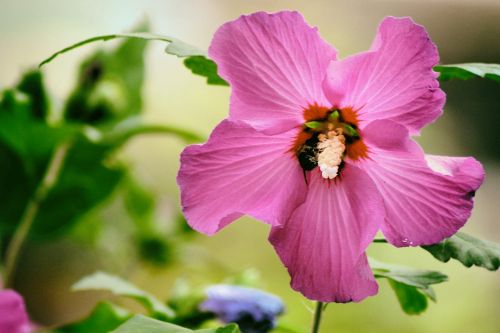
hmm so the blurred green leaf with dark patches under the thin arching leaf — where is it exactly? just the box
[64,23,148,124]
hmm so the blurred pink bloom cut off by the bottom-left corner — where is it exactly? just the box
[0,289,31,333]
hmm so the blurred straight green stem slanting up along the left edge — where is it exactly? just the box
[5,142,71,288]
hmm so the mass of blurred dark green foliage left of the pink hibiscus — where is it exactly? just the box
[0,22,202,265]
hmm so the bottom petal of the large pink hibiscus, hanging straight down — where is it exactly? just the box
[269,165,384,302]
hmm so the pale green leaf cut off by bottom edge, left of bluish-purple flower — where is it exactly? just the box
[113,315,193,333]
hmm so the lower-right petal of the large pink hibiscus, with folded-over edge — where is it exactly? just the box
[359,121,484,246]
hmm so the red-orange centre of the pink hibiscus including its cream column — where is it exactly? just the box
[294,105,367,179]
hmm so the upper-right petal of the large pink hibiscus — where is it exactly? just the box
[324,17,445,134]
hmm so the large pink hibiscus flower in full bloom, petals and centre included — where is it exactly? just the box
[178,12,484,302]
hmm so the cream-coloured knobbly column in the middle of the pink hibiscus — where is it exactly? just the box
[317,128,346,179]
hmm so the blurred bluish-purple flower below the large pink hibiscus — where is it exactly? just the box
[200,284,284,333]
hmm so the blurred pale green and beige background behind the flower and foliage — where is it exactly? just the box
[0,0,500,333]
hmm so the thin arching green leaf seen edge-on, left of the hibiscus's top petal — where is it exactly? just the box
[39,32,205,67]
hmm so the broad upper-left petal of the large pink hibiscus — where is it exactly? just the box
[209,11,336,133]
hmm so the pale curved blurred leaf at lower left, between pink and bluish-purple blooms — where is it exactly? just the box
[72,272,174,319]
